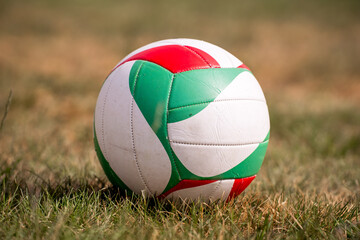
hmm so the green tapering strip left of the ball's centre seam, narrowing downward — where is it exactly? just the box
[129,60,180,191]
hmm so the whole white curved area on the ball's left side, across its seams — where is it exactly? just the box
[95,61,171,195]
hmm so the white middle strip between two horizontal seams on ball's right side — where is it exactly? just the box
[168,100,270,145]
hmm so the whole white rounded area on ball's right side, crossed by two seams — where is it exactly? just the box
[168,72,270,177]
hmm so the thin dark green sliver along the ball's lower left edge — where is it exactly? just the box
[94,126,132,194]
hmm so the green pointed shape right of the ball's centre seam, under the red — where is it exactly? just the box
[168,68,247,123]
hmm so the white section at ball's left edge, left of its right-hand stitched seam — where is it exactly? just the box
[95,62,145,193]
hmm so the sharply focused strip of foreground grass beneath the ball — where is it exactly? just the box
[0,157,360,239]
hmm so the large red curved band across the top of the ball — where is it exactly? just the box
[114,45,220,73]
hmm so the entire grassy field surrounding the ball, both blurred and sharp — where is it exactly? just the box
[0,0,360,239]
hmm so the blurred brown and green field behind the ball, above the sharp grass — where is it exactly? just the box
[0,0,360,198]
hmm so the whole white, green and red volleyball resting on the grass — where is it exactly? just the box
[94,39,270,201]
